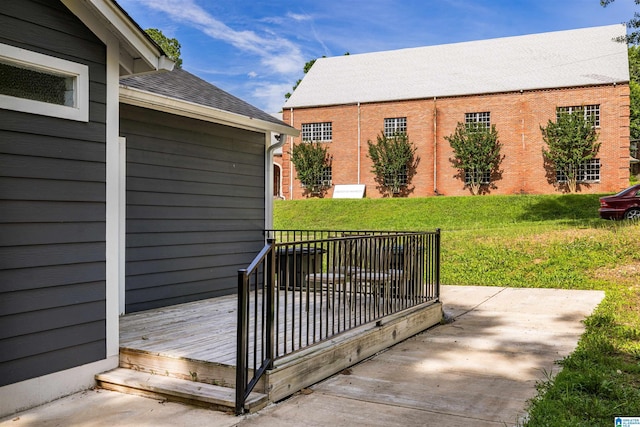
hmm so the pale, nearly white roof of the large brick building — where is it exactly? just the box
[285,24,629,108]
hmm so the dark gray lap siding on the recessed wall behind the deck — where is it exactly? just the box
[120,105,265,312]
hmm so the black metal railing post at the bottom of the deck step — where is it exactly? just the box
[236,269,249,415]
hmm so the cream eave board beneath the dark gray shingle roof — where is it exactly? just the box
[120,85,300,137]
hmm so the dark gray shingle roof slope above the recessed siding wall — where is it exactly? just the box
[120,69,288,126]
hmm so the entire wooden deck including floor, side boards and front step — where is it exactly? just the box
[111,291,442,411]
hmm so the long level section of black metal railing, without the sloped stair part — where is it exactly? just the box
[268,230,440,359]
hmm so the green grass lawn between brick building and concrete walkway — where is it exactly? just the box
[274,195,640,427]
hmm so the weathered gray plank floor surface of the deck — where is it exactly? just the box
[120,292,384,366]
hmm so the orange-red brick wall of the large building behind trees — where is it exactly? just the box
[282,84,629,199]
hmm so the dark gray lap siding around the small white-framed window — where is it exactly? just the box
[0,0,106,386]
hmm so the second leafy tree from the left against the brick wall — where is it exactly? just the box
[367,131,419,196]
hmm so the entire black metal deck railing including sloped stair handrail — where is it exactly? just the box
[236,230,440,413]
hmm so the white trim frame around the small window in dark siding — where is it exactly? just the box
[0,43,89,122]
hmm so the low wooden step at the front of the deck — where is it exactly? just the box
[96,368,268,412]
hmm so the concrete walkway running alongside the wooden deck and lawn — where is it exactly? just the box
[0,286,604,427]
